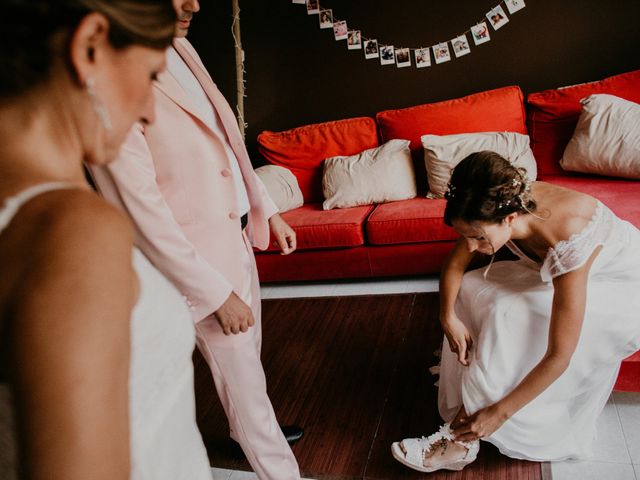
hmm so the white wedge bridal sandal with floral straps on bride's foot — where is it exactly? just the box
[391,423,480,473]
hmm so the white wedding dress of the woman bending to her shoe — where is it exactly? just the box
[438,202,640,460]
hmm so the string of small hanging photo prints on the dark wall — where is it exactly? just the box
[292,0,525,68]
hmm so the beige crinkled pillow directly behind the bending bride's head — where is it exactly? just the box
[420,132,538,198]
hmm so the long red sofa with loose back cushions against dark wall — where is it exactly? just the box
[256,70,640,391]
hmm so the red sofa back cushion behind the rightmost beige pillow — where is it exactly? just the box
[527,70,640,175]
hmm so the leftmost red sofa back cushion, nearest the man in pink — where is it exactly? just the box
[258,117,378,202]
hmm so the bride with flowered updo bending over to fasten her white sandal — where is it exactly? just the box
[392,152,640,472]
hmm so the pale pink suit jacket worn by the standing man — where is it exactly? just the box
[90,39,277,322]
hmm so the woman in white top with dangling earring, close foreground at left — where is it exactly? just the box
[0,0,211,480]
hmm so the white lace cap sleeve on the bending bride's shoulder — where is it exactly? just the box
[540,202,615,282]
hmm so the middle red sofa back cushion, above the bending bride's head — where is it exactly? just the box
[376,86,527,152]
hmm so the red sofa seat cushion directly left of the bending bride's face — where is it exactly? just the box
[366,197,458,245]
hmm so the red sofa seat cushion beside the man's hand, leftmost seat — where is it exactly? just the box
[268,203,373,251]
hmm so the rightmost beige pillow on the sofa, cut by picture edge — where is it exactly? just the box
[560,95,640,178]
